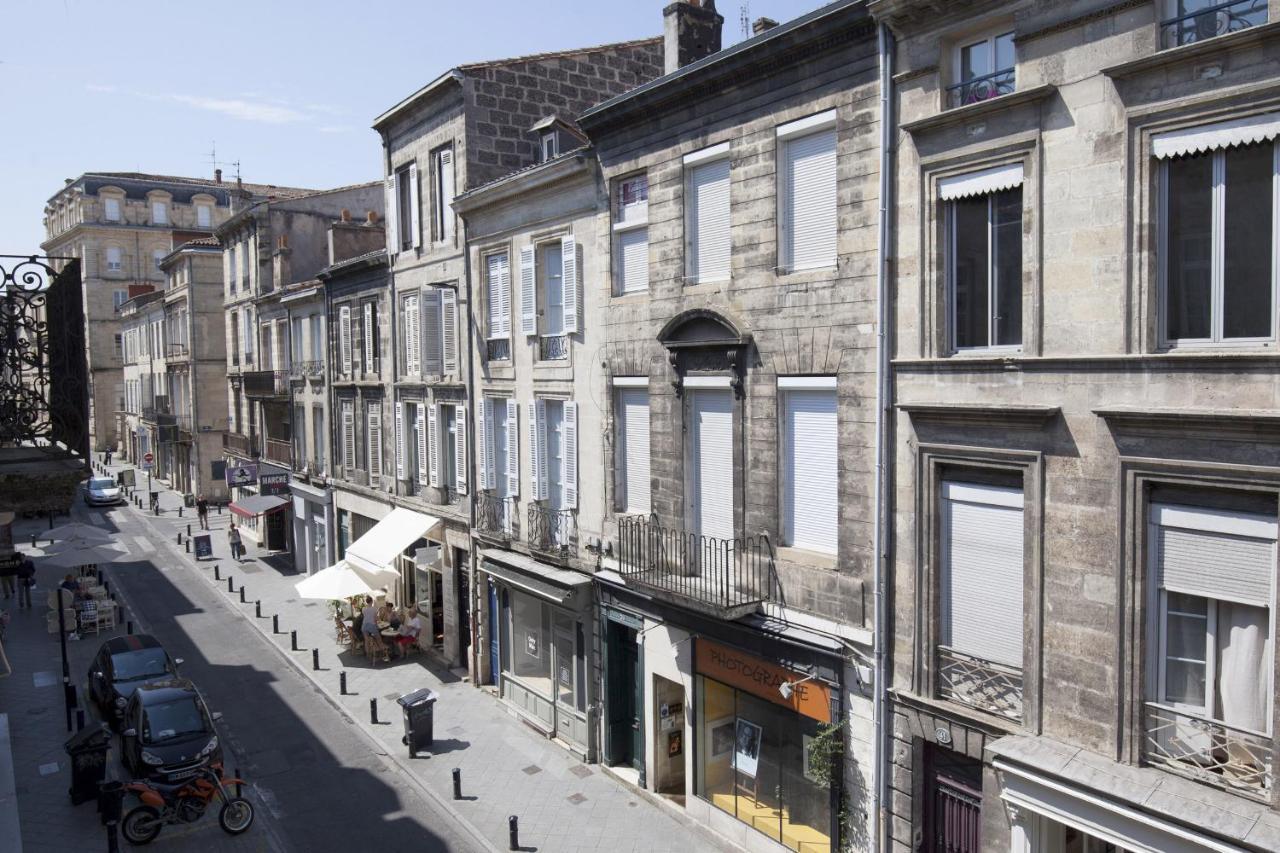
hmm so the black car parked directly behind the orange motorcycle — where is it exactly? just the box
[120,679,223,783]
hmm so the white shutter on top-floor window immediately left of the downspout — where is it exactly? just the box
[782,128,836,269]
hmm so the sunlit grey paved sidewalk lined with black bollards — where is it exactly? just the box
[94,455,737,853]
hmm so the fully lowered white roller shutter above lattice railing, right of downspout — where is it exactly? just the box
[938,483,1023,669]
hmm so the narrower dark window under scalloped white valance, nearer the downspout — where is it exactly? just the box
[938,165,1023,350]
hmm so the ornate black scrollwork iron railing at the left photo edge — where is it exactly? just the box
[0,255,88,460]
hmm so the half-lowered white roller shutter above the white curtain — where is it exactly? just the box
[1151,505,1276,607]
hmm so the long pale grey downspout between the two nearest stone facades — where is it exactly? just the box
[872,23,895,850]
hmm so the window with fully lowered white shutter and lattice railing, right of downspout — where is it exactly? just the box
[937,480,1024,721]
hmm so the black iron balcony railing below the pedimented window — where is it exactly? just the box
[618,516,777,619]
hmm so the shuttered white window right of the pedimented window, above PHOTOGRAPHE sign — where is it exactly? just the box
[778,377,840,555]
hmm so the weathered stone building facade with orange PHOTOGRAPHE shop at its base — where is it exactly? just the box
[579,1,879,850]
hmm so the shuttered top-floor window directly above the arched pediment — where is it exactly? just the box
[685,142,732,284]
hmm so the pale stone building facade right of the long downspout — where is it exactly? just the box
[870,0,1280,850]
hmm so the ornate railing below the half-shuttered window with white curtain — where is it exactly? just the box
[1142,702,1274,802]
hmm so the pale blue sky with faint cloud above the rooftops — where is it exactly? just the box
[0,0,824,254]
